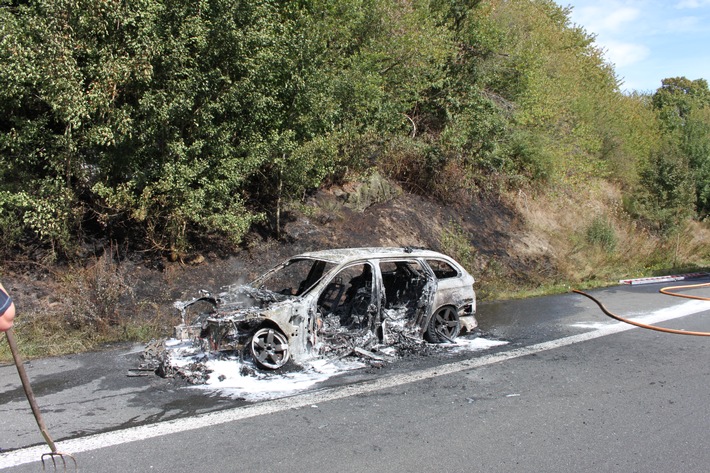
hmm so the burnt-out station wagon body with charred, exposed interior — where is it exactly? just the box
[176,248,478,369]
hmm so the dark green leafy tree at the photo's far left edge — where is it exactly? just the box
[0,0,159,254]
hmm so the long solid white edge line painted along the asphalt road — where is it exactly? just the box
[0,301,710,469]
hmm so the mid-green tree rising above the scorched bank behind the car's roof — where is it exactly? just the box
[256,0,450,226]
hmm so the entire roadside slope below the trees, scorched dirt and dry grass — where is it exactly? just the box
[0,171,710,357]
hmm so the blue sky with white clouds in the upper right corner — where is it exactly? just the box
[556,0,710,92]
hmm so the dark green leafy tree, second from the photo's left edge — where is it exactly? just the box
[92,0,278,257]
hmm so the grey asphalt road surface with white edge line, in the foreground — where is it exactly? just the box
[0,279,710,472]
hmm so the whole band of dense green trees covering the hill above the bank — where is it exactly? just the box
[0,0,710,257]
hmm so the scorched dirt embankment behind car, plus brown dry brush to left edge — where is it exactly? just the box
[2,176,554,338]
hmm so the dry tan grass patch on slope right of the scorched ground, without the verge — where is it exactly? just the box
[515,181,710,285]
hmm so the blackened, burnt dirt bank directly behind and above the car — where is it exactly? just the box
[150,175,556,298]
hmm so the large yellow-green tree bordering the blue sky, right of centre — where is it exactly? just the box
[420,0,636,190]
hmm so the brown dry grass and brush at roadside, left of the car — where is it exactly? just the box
[0,253,175,361]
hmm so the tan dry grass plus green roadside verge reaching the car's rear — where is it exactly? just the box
[474,181,710,300]
